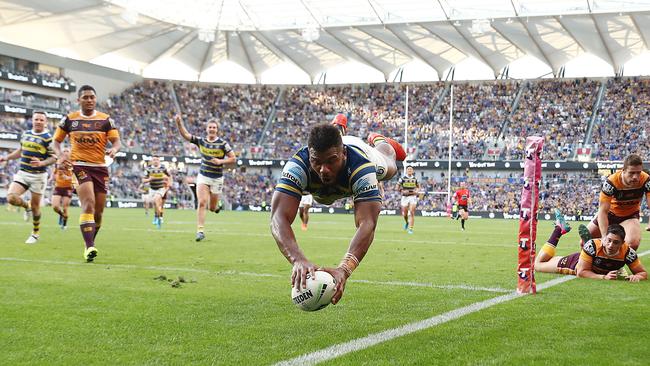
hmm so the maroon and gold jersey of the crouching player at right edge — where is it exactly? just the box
[600,171,650,217]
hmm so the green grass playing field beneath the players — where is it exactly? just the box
[0,208,650,365]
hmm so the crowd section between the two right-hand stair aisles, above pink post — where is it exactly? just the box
[503,79,600,160]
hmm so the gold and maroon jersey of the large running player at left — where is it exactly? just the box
[54,111,119,166]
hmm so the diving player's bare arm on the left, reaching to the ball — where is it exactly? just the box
[271,191,316,289]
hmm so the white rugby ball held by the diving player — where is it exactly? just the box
[291,271,336,311]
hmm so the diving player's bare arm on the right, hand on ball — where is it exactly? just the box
[325,201,381,305]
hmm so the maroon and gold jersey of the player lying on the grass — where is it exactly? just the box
[580,239,641,275]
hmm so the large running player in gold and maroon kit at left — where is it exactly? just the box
[53,85,121,262]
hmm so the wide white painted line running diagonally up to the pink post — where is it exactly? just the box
[275,250,650,366]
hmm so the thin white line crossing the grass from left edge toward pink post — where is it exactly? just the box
[0,257,511,293]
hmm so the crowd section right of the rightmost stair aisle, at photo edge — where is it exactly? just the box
[591,78,650,160]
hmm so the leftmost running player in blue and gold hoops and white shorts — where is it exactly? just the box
[0,112,56,244]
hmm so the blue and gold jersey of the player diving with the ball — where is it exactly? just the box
[275,145,381,205]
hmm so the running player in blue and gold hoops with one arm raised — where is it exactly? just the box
[174,115,235,241]
